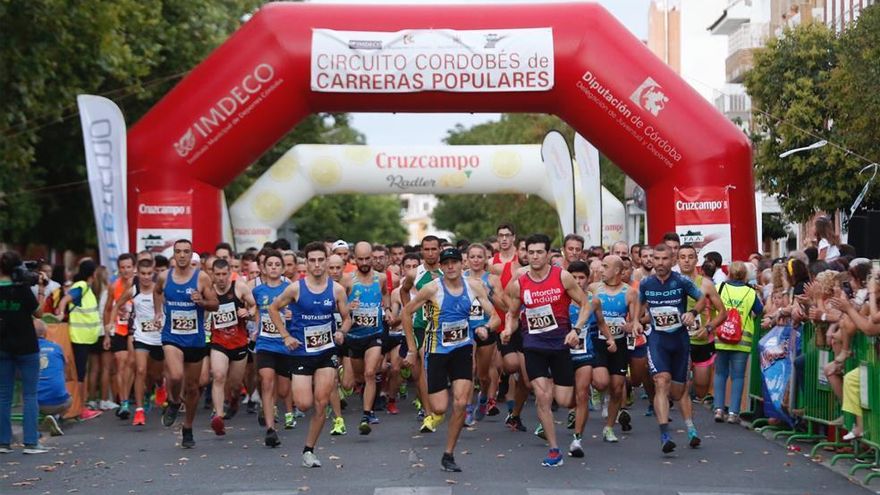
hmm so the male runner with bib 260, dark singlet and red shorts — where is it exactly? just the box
[211,258,257,435]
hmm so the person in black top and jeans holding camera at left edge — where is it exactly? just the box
[0,251,47,454]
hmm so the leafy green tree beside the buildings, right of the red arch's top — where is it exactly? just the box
[745,23,862,221]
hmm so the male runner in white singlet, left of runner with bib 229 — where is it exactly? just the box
[110,259,165,426]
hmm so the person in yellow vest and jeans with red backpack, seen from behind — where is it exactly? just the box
[715,261,764,424]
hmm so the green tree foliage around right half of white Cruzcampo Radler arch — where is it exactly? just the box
[434,114,625,240]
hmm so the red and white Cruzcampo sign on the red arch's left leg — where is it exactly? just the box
[137,191,192,257]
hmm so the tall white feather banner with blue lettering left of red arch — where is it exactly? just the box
[76,95,128,268]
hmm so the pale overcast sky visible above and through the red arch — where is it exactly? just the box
[311,0,650,145]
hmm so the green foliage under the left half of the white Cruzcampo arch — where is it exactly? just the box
[293,194,406,246]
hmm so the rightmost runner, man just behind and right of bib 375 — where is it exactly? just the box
[678,244,727,404]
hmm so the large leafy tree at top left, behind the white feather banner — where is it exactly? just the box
[0,0,262,249]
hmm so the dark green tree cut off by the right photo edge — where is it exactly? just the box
[829,5,880,208]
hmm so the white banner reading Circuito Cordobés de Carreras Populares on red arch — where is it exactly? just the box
[311,28,554,93]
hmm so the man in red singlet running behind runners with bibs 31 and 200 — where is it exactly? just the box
[486,223,529,431]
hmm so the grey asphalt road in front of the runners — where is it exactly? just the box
[0,392,871,495]
